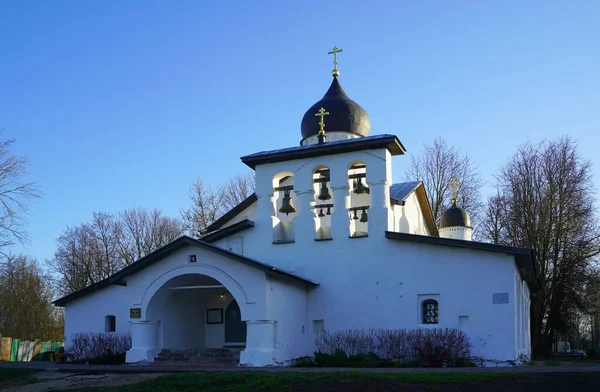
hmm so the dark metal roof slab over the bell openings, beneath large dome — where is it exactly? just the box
[240,134,406,169]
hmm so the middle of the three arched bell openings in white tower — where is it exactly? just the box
[312,166,334,240]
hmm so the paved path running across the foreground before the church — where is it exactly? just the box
[0,362,600,374]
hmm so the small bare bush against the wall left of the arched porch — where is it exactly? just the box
[66,333,131,364]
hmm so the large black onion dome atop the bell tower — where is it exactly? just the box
[301,77,371,140]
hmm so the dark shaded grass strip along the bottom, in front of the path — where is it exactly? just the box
[65,372,600,392]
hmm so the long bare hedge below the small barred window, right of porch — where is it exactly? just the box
[295,328,471,367]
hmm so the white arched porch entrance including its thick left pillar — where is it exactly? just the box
[127,268,253,362]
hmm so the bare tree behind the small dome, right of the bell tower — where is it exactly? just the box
[404,138,483,230]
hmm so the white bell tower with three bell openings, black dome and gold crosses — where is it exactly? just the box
[242,47,405,245]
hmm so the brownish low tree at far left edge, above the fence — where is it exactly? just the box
[0,255,63,340]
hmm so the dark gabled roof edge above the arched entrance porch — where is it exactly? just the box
[53,236,319,306]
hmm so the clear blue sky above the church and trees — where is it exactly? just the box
[0,0,600,260]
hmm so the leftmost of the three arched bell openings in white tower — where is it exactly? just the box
[273,171,297,243]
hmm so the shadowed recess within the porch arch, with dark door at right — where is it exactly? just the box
[146,273,246,351]
